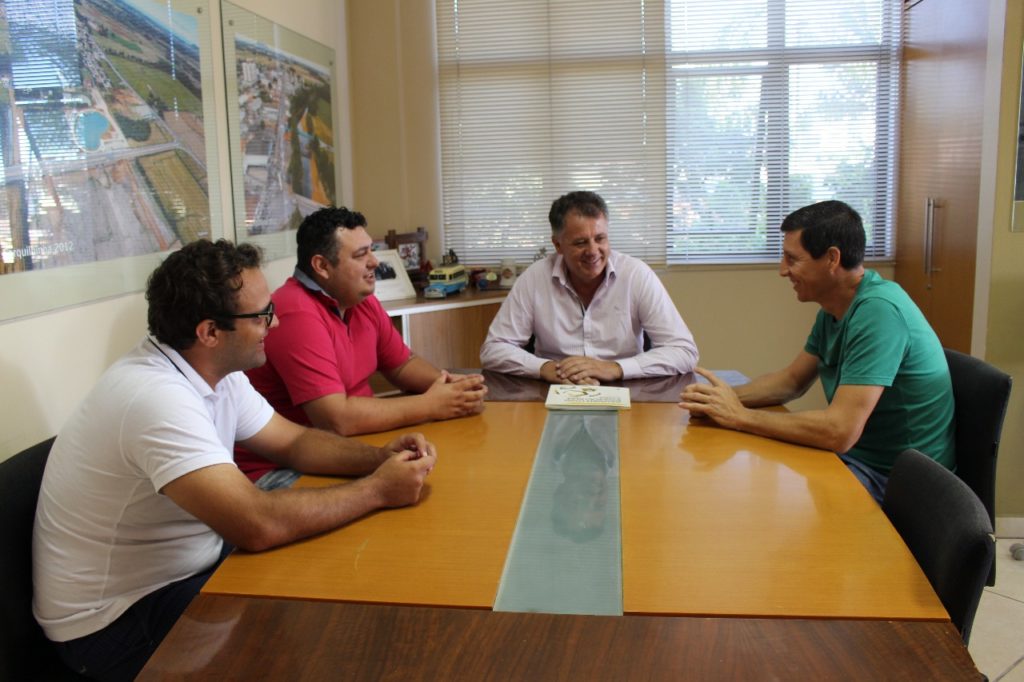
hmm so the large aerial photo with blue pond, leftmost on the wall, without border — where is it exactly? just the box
[0,0,210,274]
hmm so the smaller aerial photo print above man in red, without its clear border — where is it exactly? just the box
[234,35,335,236]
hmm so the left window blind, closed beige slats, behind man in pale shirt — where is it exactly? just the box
[437,0,665,264]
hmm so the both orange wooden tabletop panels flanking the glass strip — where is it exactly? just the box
[204,402,947,621]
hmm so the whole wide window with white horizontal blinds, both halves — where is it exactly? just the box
[437,0,901,264]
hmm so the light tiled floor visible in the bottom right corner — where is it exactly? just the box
[968,538,1024,682]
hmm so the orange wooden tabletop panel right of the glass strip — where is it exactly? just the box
[620,403,947,620]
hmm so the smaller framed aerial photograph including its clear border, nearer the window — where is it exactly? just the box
[221,1,339,258]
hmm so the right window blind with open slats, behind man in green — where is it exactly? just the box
[666,0,901,263]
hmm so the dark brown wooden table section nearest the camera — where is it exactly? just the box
[137,594,980,682]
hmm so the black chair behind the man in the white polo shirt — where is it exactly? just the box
[0,438,85,680]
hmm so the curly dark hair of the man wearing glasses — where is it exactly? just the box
[145,240,262,350]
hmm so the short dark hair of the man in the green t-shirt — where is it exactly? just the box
[780,200,866,270]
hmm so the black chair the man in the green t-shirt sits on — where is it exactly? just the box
[945,348,1013,585]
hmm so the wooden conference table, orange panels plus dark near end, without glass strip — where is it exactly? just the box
[139,374,979,679]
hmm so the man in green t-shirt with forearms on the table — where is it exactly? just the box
[679,201,955,502]
